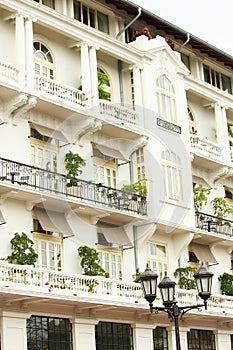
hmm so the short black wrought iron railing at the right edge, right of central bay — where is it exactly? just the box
[196,212,233,237]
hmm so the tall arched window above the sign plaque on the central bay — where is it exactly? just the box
[156,74,177,124]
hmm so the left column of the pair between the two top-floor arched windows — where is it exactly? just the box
[81,42,91,97]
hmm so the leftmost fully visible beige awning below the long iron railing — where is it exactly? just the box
[34,208,74,236]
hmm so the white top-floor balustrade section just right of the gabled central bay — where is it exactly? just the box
[190,135,222,160]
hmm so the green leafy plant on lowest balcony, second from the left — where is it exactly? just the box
[78,246,105,276]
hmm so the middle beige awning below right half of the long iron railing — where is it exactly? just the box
[97,226,133,247]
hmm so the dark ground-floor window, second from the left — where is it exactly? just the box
[95,322,133,350]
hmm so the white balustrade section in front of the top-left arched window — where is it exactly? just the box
[35,76,88,107]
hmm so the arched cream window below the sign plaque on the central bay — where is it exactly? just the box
[161,150,183,200]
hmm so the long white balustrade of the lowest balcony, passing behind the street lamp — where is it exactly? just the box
[0,261,233,317]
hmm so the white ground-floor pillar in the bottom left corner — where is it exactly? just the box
[0,311,29,350]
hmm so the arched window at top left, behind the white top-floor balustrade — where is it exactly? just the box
[33,41,54,79]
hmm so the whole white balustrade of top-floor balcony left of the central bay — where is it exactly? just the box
[0,61,139,126]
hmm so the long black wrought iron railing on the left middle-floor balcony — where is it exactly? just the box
[0,158,147,215]
